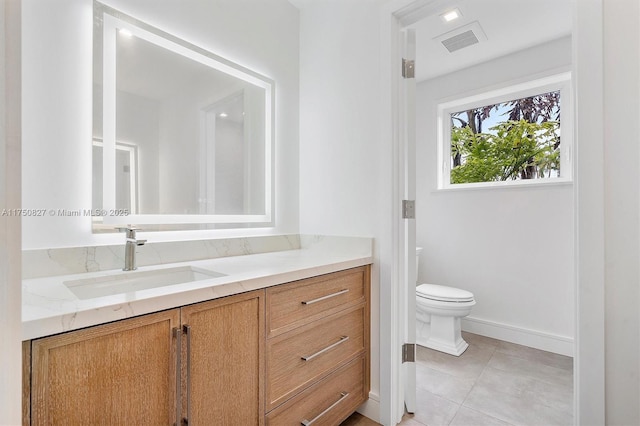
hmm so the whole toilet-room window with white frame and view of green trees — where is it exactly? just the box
[438,73,572,189]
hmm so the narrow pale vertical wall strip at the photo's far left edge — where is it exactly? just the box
[0,1,22,425]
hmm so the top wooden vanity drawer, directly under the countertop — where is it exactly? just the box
[267,267,369,337]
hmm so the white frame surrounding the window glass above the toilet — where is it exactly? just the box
[437,72,573,190]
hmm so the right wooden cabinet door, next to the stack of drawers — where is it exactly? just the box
[182,290,265,426]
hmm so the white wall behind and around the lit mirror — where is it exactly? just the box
[22,0,299,249]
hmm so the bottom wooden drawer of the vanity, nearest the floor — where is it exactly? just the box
[266,356,369,426]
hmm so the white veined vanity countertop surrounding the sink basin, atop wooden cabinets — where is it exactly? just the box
[22,244,372,340]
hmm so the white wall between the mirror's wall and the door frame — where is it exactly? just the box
[296,0,392,418]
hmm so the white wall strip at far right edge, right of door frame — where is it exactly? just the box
[604,0,640,425]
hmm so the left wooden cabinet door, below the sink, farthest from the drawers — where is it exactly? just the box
[31,309,180,425]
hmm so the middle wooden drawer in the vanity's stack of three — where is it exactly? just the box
[267,305,367,410]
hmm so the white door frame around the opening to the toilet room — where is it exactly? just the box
[380,0,605,425]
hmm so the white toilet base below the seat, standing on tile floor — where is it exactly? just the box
[416,315,469,356]
